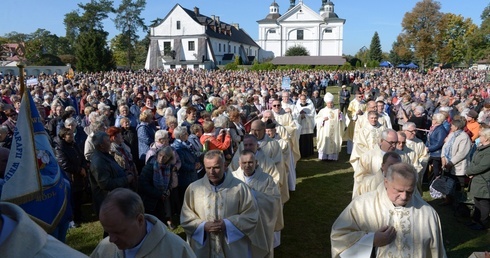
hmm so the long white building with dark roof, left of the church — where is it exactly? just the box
[145,4,260,69]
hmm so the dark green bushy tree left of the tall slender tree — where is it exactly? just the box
[75,30,115,72]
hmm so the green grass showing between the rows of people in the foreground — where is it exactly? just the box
[67,87,490,258]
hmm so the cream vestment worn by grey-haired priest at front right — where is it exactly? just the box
[330,184,446,258]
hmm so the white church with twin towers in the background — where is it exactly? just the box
[257,0,345,57]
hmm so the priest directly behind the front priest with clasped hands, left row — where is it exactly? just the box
[233,150,284,257]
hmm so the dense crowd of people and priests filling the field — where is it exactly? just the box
[0,68,490,257]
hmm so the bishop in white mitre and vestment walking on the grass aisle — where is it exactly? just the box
[315,92,345,160]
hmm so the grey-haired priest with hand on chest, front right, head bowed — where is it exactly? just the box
[330,163,447,258]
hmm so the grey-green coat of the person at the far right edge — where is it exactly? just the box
[466,144,490,199]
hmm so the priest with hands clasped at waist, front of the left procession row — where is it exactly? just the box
[180,150,261,258]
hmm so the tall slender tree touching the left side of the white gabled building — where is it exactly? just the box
[114,0,147,69]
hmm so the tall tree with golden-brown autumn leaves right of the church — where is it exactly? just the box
[402,0,442,69]
